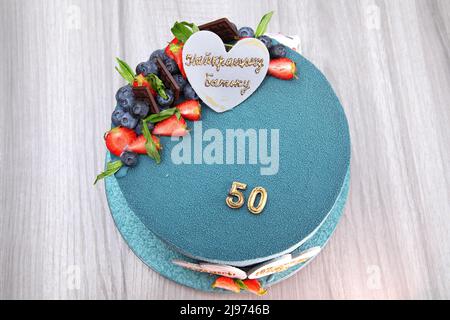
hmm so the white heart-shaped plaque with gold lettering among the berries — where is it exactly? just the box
[183,31,270,112]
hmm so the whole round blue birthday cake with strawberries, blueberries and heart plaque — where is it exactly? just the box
[96,12,350,294]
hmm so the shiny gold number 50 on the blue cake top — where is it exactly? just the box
[225,182,267,214]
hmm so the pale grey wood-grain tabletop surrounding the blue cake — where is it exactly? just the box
[0,0,450,299]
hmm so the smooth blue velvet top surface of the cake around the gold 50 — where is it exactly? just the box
[112,51,350,266]
